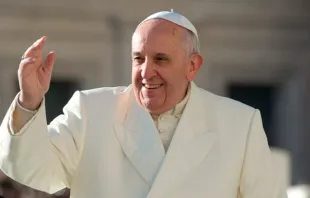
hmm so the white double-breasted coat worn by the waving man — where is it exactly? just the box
[0,83,286,198]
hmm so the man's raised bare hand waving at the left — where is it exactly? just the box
[18,36,55,110]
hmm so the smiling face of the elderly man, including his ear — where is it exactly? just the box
[132,19,202,114]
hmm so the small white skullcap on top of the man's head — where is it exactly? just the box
[139,10,198,40]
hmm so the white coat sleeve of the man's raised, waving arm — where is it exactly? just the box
[0,92,87,194]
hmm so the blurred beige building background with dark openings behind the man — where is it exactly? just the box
[0,0,310,198]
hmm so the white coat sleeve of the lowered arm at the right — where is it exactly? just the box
[240,110,287,198]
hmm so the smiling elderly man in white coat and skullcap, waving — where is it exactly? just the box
[0,11,286,198]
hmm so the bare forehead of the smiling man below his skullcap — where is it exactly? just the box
[132,19,186,53]
